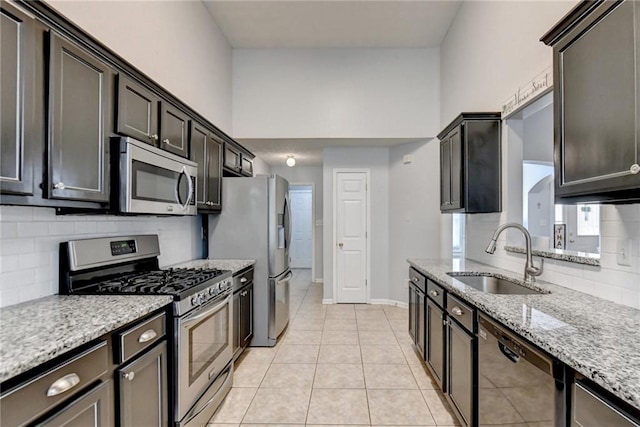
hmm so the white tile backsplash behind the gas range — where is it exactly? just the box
[0,206,202,307]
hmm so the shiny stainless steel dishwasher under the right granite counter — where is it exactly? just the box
[478,314,566,426]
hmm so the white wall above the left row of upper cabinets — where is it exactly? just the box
[47,0,232,134]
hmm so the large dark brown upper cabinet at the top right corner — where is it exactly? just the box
[541,0,640,204]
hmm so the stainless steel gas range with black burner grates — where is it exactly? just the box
[59,235,233,427]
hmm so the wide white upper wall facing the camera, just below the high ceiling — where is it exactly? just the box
[233,49,440,139]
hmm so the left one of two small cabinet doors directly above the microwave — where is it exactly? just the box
[116,74,160,145]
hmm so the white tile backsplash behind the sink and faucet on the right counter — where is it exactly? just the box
[466,204,640,308]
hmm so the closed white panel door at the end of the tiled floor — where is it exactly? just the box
[334,172,369,303]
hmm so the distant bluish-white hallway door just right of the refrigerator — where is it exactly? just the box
[289,186,313,268]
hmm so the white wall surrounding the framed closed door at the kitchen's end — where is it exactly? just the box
[323,147,389,300]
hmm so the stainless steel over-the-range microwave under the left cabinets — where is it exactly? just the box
[112,137,198,215]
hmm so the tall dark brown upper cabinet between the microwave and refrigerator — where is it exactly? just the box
[191,121,223,211]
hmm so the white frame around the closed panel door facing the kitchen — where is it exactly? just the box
[331,168,371,304]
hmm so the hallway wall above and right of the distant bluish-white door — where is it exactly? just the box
[271,166,324,282]
